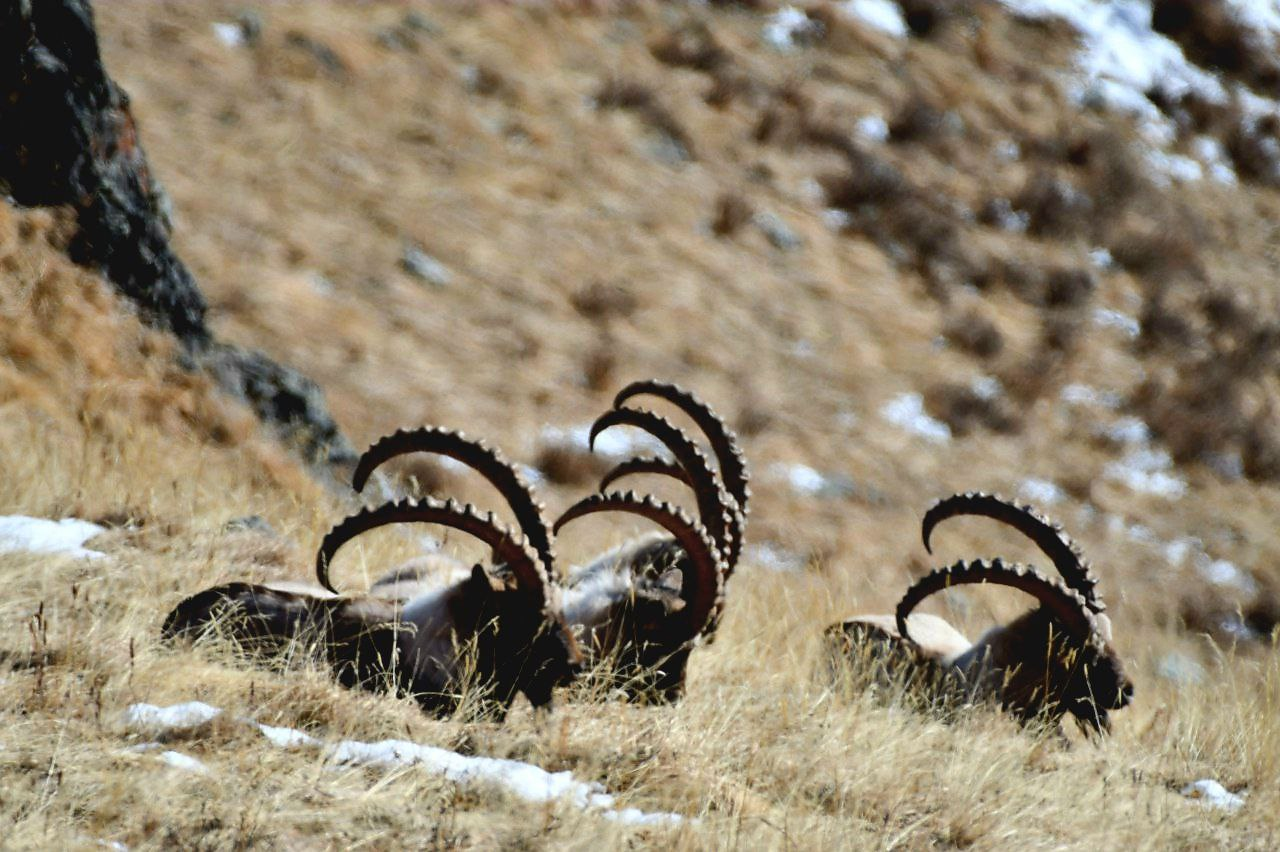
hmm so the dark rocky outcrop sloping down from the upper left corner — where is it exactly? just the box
[0,0,355,467]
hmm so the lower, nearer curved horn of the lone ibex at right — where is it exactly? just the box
[895,559,1097,640]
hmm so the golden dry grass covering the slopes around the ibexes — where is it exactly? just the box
[0,0,1280,848]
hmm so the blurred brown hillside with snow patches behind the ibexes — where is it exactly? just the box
[0,0,1280,654]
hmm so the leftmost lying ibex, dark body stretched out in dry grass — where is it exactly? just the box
[164,430,581,716]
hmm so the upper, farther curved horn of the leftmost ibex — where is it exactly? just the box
[351,426,556,576]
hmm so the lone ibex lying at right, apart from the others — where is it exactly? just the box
[827,495,1133,730]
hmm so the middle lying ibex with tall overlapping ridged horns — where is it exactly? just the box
[545,381,750,701]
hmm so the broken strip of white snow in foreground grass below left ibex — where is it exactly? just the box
[124,701,685,825]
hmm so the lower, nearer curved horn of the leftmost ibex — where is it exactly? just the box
[316,498,547,605]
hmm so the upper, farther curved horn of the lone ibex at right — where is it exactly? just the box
[920,491,1106,613]
